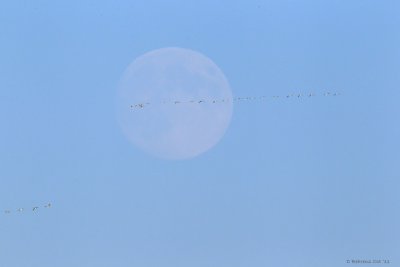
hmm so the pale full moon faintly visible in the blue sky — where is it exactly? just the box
[117,47,233,160]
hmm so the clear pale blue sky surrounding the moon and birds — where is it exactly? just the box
[0,0,400,267]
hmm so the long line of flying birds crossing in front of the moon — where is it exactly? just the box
[131,92,340,109]
